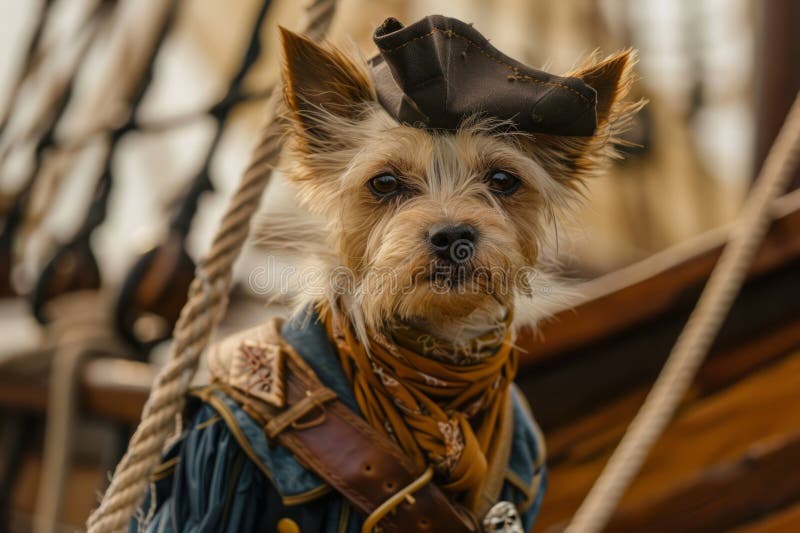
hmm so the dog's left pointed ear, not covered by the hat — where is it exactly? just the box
[280,28,375,150]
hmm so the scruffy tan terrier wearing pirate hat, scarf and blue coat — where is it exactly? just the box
[138,16,642,532]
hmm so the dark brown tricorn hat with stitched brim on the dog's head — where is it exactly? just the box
[370,15,597,136]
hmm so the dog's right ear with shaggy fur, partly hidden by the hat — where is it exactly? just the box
[532,49,645,185]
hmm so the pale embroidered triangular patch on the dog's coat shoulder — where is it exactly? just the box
[208,319,286,408]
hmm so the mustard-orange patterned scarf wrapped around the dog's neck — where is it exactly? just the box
[325,312,517,510]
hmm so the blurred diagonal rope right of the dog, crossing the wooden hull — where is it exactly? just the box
[566,93,800,533]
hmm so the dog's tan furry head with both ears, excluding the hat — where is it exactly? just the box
[283,31,635,327]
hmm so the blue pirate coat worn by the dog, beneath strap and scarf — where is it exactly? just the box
[130,317,546,533]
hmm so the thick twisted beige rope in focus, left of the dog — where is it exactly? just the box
[87,0,335,533]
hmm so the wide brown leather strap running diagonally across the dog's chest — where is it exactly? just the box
[223,336,480,533]
